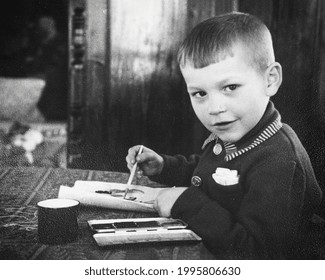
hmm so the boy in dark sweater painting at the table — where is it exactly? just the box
[126,13,322,259]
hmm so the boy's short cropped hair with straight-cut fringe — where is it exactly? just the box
[178,12,275,71]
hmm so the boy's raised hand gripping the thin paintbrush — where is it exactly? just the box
[126,145,164,176]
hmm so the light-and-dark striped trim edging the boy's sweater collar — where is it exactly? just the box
[202,116,282,161]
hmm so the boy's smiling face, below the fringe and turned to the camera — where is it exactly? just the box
[181,43,269,143]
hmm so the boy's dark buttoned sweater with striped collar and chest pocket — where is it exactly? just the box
[154,102,322,259]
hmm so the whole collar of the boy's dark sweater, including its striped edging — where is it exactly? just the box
[202,101,282,161]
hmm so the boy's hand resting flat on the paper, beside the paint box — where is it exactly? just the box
[153,187,187,217]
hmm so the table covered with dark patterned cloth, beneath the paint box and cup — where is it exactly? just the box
[0,167,213,260]
